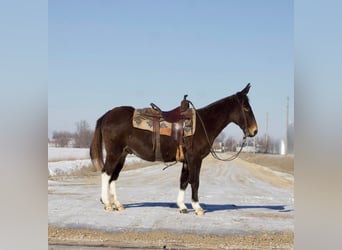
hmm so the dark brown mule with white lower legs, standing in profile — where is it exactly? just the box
[90,84,258,215]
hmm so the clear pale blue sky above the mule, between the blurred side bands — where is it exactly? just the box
[48,0,294,141]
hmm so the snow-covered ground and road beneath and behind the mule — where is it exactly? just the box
[48,146,294,235]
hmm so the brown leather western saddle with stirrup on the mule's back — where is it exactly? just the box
[144,95,192,161]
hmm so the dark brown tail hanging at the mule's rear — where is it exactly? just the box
[90,117,104,170]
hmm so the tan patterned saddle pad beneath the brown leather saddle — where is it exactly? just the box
[132,108,196,137]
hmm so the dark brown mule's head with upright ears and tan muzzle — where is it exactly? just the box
[235,83,258,137]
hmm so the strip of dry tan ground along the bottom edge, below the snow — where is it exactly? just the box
[48,226,294,249]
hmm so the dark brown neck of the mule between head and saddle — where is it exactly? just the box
[198,95,238,143]
